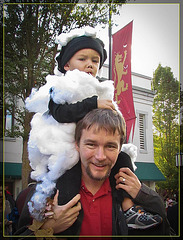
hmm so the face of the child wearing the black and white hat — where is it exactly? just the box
[64,48,100,77]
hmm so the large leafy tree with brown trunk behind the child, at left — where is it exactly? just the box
[4,0,125,187]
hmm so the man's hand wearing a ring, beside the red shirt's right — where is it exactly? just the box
[115,168,141,198]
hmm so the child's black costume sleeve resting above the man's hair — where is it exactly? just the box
[48,96,97,123]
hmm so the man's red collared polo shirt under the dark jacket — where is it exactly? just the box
[80,178,112,236]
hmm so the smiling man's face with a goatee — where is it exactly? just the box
[76,125,120,181]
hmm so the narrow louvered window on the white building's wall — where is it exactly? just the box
[139,113,147,150]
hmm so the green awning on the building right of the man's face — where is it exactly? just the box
[135,162,166,181]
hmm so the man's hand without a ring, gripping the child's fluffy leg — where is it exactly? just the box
[42,190,81,234]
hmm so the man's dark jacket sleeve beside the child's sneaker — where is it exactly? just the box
[133,183,170,235]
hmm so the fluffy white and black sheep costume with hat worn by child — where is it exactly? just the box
[26,29,137,223]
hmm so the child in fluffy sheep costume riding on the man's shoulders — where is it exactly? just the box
[26,26,161,229]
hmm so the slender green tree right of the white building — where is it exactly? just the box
[153,64,180,195]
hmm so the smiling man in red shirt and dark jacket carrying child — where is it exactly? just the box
[15,109,169,236]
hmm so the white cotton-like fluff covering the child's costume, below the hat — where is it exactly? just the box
[26,70,137,219]
